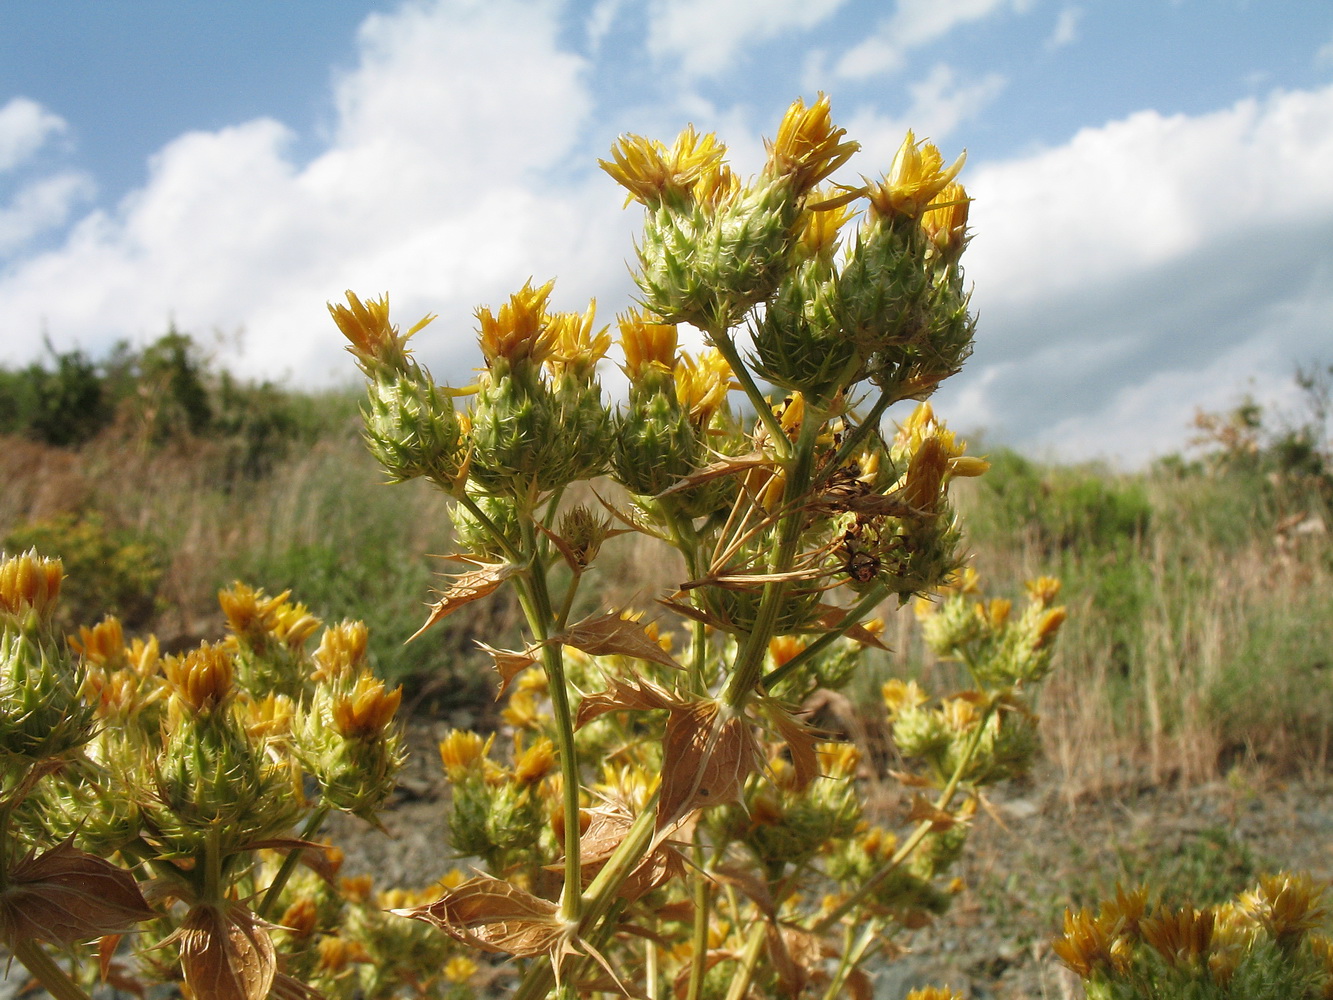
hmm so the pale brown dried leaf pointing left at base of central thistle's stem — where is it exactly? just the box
[391,875,567,960]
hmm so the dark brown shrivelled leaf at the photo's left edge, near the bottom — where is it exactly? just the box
[0,840,157,944]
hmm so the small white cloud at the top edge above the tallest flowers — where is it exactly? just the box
[648,0,845,77]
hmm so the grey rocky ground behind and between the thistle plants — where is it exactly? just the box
[319,723,1333,1000]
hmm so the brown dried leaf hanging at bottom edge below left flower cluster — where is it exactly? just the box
[173,903,277,1000]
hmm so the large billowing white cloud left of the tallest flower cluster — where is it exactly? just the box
[0,0,631,383]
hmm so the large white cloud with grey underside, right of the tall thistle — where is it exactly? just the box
[948,88,1333,461]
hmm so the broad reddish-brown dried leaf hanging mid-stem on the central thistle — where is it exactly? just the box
[656,699,762,836]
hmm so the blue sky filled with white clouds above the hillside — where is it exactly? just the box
[0,0,1333,464]
